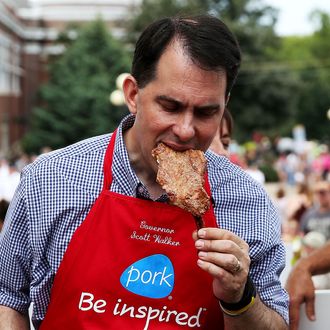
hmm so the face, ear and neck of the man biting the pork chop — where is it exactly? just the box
[124,43,226,177]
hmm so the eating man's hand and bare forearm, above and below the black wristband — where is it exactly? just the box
[193,228,288,330]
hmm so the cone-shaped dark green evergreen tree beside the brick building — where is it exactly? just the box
[23,20,130,152]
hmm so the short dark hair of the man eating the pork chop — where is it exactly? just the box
[132,15,241,95]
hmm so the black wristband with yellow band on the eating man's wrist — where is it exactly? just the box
[219,276,257,316]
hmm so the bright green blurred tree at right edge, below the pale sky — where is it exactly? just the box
[275,11,330,142]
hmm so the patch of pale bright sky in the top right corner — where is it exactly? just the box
[264,0,330,35]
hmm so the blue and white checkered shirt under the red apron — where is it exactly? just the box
[0,116,288,324]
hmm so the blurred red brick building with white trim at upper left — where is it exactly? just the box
[0,0,140,155]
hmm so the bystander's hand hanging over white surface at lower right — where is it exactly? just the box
[286,263,315,330]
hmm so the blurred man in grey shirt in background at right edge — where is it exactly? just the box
[301,181,330,240]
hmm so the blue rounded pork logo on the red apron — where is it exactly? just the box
[120,254,174,299]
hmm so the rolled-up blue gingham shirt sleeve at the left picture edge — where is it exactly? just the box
[0,171,31,313]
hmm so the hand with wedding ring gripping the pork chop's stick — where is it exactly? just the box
[194,228,250,303]
